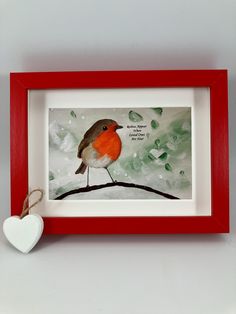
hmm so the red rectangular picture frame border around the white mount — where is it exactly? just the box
[10,70,229,234]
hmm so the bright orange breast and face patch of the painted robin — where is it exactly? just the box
[92,131,121,160]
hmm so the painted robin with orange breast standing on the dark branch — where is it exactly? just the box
[75,119,123,186]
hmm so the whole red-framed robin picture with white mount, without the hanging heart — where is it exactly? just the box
[11,70,229,234]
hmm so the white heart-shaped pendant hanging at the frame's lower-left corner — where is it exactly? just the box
[3,214,44,253]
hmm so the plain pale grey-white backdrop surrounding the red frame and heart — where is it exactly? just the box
[0,0,236,314]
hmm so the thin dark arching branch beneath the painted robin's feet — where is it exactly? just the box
[55,181,179,200]
